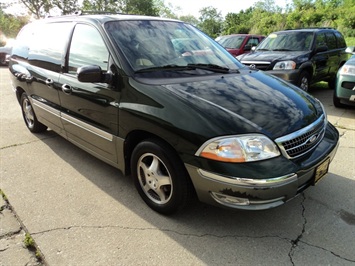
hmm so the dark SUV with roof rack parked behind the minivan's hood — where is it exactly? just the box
[237,28,349,91]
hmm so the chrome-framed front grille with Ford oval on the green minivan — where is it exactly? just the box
[276,116,325,159]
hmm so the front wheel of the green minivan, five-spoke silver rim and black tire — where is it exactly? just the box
[131,139,192,214]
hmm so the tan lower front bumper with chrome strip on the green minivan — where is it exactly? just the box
[186,165,302,210]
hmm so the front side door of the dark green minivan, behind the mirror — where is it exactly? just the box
[59,24,119,164]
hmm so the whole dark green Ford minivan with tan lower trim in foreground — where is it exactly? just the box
[9,15,339,214]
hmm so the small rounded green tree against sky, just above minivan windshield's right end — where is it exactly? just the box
[197,6,223,38]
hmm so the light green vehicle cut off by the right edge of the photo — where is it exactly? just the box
[333,47,355,107]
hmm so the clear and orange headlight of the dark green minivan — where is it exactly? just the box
[196,134,280,163]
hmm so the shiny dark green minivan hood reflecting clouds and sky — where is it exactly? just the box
[163,69,322,139]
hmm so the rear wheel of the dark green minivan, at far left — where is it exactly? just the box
[20,92,47,133]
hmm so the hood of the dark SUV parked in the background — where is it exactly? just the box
[237,51,309,63]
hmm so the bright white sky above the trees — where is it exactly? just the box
[164,0,291,18]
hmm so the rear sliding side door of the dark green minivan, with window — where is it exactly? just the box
[26,22,72,137]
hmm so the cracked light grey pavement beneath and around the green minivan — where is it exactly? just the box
[0,68,355,266]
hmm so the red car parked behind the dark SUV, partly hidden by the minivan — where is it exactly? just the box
[216,34,265,56]
